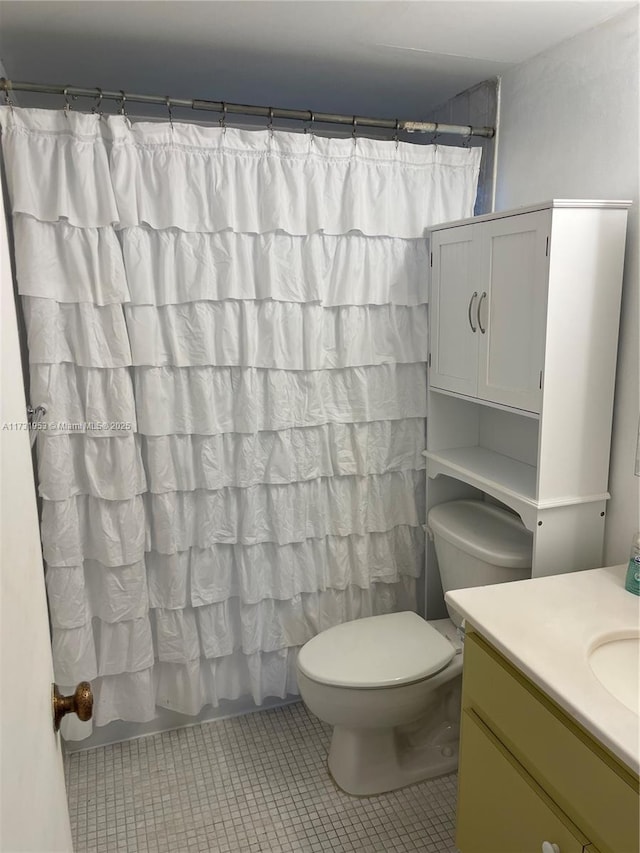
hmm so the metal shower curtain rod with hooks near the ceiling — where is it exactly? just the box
[0,77,495,139]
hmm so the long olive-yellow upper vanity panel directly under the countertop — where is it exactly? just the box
[462,633,639,853]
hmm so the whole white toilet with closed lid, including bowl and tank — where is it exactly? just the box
[297,501,532,796]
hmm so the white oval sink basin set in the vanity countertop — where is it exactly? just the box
[589,631,640,714]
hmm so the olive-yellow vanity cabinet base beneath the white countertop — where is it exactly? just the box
[456,631,640,853]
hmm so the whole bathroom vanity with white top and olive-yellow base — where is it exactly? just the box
[447,566,640,853]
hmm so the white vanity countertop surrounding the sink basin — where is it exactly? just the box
[446,566,640,773]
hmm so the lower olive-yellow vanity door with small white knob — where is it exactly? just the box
[456,711,590,853]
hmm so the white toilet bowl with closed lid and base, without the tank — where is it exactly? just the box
[297,611,462,796]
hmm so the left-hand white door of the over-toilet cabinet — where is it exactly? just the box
[429,225,479,397]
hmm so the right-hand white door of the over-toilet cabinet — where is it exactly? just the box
[477,210,551,412]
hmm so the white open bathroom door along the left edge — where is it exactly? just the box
[0,185,72,853]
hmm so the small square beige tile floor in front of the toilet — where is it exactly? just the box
[65,703,456,853]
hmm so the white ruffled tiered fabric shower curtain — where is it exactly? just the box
[0,107,479,737]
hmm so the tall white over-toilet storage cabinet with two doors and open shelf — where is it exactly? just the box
[425,200,630,604]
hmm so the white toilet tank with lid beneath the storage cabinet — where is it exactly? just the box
[427,500,533,625]
